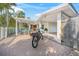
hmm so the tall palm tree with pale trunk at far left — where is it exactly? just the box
[0,3,16,37]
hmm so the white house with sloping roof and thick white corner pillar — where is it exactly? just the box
[37,4,77,41]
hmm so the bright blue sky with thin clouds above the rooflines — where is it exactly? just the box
[17,3,79,20]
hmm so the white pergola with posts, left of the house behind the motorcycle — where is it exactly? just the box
[15,18,39,36]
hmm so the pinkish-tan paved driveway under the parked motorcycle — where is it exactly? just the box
[0,35,77,56]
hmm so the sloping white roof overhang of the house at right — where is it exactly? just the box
[37,3,77,22]
